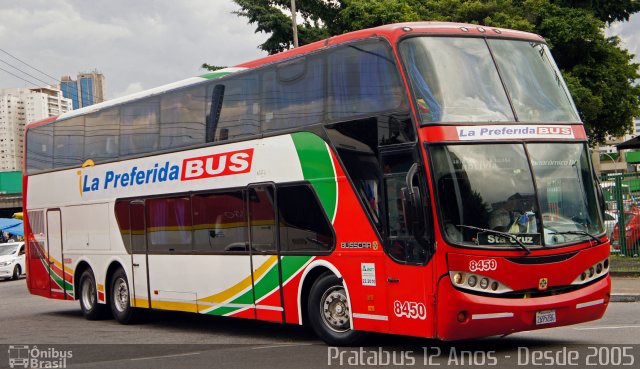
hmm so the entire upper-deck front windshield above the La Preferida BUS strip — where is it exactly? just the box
[400,37,580,124]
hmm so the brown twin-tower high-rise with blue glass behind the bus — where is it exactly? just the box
[60,70,104,110]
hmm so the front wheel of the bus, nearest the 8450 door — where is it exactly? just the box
[307,274,365,346]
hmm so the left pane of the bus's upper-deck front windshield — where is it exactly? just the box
[400,37,515,123]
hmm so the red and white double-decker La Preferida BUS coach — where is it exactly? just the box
[24,22,610,344]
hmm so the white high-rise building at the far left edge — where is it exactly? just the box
[0,87,71,172]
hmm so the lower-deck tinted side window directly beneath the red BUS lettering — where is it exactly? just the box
[192,191,248,252]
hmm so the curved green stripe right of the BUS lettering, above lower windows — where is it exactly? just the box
[291,132,338,223]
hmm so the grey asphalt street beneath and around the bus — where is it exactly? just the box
[0,279,640,369]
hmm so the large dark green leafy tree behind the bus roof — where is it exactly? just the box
[234,0,640,143]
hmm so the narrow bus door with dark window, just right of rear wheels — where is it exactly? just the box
[129,200,151,308]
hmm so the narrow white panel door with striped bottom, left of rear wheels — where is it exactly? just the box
[47,209,66,298]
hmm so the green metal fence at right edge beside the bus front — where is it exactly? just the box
[600,173,640,273]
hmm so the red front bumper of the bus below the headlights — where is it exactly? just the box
[436,275,611,340]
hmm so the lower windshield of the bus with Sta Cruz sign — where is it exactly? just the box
[431,143,603,246]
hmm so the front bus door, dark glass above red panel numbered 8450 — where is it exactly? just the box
[382,157,435,335]
